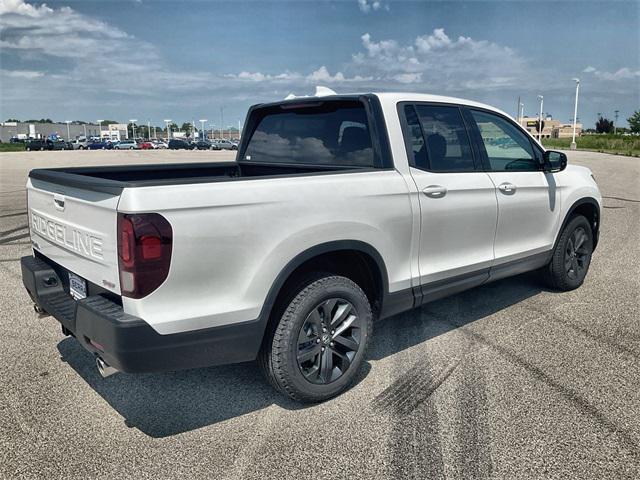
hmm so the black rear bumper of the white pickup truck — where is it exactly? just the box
[20,256,265,373]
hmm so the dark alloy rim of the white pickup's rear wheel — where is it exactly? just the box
[297,298,361,385]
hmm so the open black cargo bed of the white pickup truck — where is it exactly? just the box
[29,162,362,195]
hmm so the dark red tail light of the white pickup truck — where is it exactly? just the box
[118,213,173,298]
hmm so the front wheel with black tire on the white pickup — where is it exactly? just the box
[544,215,593,292]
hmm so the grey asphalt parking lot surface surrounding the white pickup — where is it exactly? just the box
[0,151,640,479]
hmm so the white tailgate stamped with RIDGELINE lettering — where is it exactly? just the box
[27,178,120,294]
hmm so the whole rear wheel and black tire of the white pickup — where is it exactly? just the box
[258,274,373,403]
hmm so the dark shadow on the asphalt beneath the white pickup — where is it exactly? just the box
[58,274,542,438]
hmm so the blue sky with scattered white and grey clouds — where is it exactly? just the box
[0,0,640,128]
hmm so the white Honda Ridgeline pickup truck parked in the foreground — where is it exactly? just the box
[22,93,601,402]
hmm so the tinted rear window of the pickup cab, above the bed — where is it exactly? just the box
[243,100,373,167]
